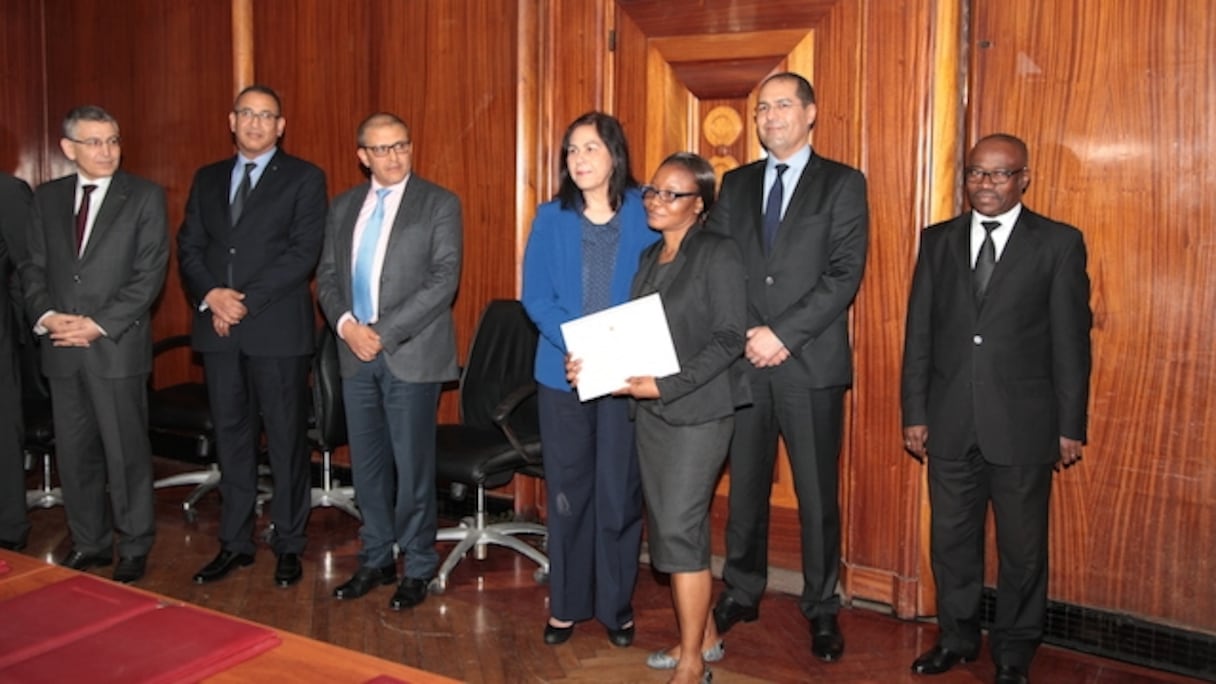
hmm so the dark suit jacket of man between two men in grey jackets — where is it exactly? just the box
[178,150,328,357]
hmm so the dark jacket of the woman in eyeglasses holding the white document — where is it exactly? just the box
[630,228,750,425]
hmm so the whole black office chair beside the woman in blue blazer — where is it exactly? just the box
[430,299,548,594]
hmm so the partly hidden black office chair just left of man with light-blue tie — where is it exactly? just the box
[308,325,364,520]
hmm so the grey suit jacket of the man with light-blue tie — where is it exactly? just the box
[316,174,462,382]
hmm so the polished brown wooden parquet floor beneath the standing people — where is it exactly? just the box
[9,460,1195,684]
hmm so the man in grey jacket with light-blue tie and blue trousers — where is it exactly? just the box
[316,113,462,610]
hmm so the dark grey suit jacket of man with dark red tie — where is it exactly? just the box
[21,170,169,377]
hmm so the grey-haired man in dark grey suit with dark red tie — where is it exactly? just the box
[21,106,169,582]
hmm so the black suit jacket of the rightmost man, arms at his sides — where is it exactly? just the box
[902,207,1092,465]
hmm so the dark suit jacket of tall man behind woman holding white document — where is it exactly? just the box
[709,152,869,388]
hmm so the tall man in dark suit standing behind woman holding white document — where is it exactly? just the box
[709,72,869,661]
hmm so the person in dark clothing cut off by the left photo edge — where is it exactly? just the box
[0,173,30,550]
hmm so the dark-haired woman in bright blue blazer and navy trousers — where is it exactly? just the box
[522,112,657,646]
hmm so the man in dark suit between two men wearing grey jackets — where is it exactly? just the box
[178,85,327,587]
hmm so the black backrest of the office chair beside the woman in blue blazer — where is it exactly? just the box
[460,299,537,437]
